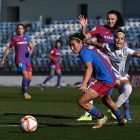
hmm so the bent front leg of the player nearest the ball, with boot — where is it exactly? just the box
[78,88,107,128]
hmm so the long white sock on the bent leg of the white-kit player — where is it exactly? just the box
[116,84,132,107]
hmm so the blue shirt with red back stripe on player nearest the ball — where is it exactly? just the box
[80,45,116,84]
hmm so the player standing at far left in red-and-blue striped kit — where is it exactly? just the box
[1,24,34,99]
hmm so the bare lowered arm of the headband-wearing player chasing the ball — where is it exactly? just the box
[77,62,93,92]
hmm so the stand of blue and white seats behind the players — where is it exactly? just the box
[0,18,140,71]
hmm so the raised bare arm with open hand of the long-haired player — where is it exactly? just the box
[77,15,92,40]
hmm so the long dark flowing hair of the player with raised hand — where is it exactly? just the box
[107,10,124,29]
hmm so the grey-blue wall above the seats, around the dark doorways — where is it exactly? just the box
[2,0,122,23]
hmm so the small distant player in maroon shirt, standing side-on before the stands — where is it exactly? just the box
[41,40,62,90]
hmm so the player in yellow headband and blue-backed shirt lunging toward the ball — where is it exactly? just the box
[69,33,127,129]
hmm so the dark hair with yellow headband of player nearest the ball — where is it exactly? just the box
[69,33,86,43]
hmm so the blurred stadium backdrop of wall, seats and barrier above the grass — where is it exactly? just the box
[0,0,140,87]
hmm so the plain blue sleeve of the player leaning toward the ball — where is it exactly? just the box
[80,50,93,64]
